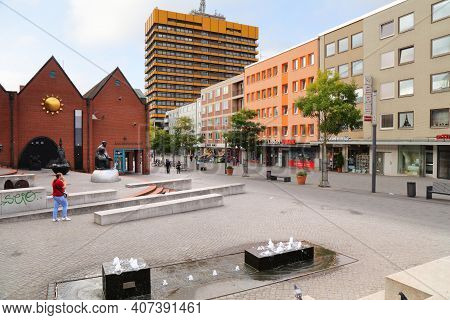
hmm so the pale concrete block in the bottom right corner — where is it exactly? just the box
[385,257,450,300]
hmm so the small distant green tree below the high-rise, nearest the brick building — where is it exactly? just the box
[172,117,202,167]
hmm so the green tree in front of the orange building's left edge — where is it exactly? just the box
[224,110,266,177]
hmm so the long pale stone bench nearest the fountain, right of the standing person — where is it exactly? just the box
[94,194,223,226]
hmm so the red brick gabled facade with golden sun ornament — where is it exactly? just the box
[0,57,149,173]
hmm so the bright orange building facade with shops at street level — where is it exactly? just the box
[244,39,319,169]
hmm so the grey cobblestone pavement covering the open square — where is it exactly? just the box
[0,166,450,299]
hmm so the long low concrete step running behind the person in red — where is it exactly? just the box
[0,183,245,223]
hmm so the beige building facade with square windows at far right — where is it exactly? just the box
[319,0,450,179]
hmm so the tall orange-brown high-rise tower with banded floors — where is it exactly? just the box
[145,2,259,126]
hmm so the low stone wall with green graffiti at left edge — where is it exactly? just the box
[0,188,47,215]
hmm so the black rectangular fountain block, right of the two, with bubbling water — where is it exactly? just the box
[245,245,314,271]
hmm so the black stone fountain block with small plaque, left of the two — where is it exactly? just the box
[102,259,151,300]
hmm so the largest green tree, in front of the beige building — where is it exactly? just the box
[295,71,362,187]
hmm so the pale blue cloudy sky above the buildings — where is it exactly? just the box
[0,0,393,93]
